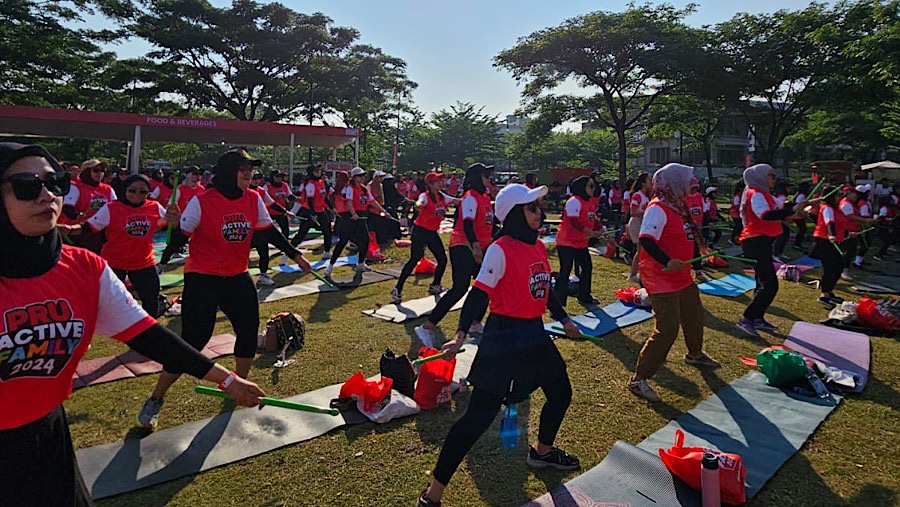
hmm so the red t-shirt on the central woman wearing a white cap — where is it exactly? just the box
[474,236,551,319]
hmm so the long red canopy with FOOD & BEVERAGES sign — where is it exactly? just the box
[0,105,359,180]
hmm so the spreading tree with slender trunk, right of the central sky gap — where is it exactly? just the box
[494,4,698,183]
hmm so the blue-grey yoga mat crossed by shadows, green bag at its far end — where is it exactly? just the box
[638,371,841,505]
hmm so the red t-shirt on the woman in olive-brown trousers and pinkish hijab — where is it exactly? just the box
[638,199,694,294]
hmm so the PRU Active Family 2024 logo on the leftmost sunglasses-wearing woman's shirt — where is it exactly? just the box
[0,299,84,382]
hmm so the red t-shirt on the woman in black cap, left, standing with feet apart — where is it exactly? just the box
[181,189,272,276]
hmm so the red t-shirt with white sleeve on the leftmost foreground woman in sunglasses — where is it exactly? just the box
[0,245,156,430]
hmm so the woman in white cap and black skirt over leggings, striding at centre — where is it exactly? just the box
[416,184,581,507]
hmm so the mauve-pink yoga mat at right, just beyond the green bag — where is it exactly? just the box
[784,322,872,393]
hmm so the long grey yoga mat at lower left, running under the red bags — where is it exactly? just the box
[76,344,477,500]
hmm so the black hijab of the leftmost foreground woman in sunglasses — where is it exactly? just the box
[0,143,63,278]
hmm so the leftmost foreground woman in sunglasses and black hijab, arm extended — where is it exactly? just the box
[0,143,264,506]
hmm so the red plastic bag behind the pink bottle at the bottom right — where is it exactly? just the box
[659,430,747,505]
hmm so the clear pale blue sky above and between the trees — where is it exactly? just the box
[102,0,828,119]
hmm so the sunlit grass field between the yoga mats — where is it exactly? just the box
[66,236,900,507]
